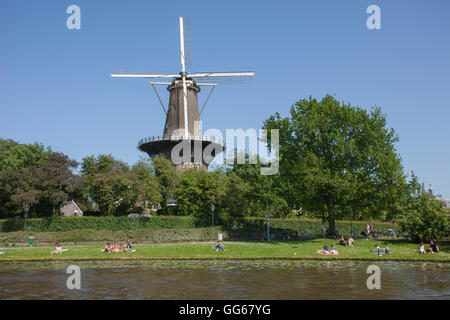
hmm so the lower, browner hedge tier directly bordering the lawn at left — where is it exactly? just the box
[0,227,226,246]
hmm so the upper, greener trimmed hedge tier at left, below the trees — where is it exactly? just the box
[0,216,200,232]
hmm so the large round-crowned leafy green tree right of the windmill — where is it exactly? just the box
[264,95,405,235]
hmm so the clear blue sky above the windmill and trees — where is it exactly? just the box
[0,0,450,198]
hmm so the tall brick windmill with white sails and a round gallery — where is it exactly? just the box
[111,17,255,169]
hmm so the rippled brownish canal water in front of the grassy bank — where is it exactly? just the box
[0,260,450,300]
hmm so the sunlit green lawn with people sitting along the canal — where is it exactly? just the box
[0,239,450,262]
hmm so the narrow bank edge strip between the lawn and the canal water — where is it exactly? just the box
[0,256,450,264]
